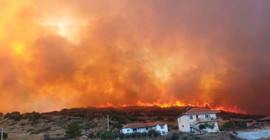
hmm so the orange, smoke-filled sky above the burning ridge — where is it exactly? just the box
[0,0,270,114]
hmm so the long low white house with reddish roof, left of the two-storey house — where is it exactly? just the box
[121,122,168,135]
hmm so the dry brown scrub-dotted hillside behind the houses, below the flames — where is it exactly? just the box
[0,107,263,140]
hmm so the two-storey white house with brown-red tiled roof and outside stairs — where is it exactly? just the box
[177,107,221,133]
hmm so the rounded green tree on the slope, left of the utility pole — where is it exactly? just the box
[66,122,82,138]
